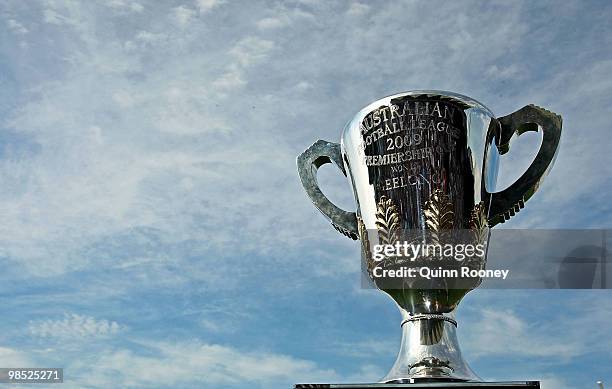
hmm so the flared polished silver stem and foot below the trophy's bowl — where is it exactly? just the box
[381,309,481,383]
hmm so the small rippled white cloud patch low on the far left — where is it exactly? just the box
[28,313,123,340]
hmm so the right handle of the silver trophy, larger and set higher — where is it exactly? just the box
[485,104,562,227]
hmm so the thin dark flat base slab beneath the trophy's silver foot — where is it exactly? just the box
[293,381,540,389]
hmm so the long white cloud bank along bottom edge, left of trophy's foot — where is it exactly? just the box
[70,341,339,387]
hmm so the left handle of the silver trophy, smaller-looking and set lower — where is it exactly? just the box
[297,140,358,240]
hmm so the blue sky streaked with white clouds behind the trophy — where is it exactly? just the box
[0,0,612,389]
